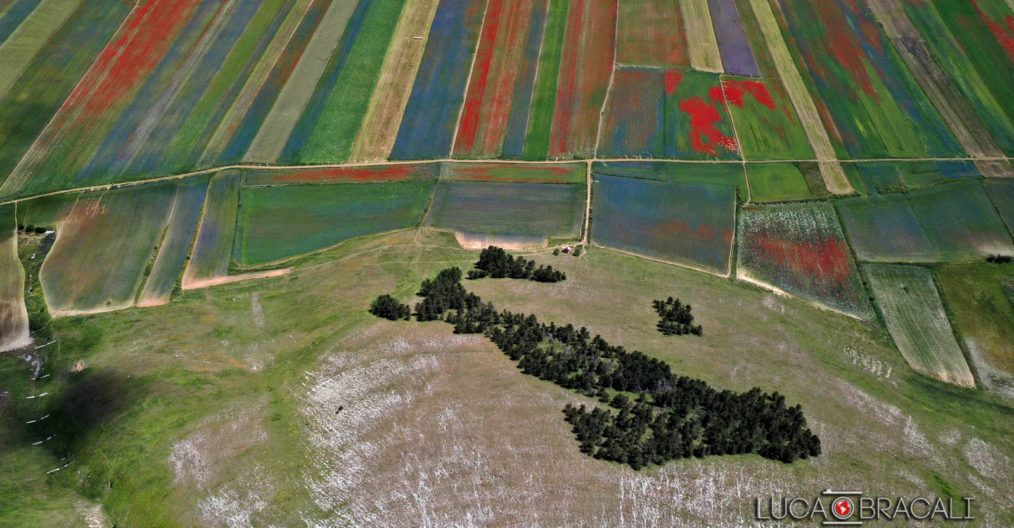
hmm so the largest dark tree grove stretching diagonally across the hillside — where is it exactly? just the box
[399,269,820,469]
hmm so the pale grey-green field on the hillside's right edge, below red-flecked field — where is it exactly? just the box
[866,265,975,386]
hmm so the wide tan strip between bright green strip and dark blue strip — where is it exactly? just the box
[349,0,439,162]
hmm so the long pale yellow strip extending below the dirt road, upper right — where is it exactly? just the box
[750,0,855,195]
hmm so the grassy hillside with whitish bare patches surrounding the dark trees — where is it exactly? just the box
[0,230,1014,526]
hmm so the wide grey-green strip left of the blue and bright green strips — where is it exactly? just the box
[243,2,356,163]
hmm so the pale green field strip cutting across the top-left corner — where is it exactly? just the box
[0,0,82,98]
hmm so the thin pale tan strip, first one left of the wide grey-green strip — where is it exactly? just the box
[198,0,311,166]
